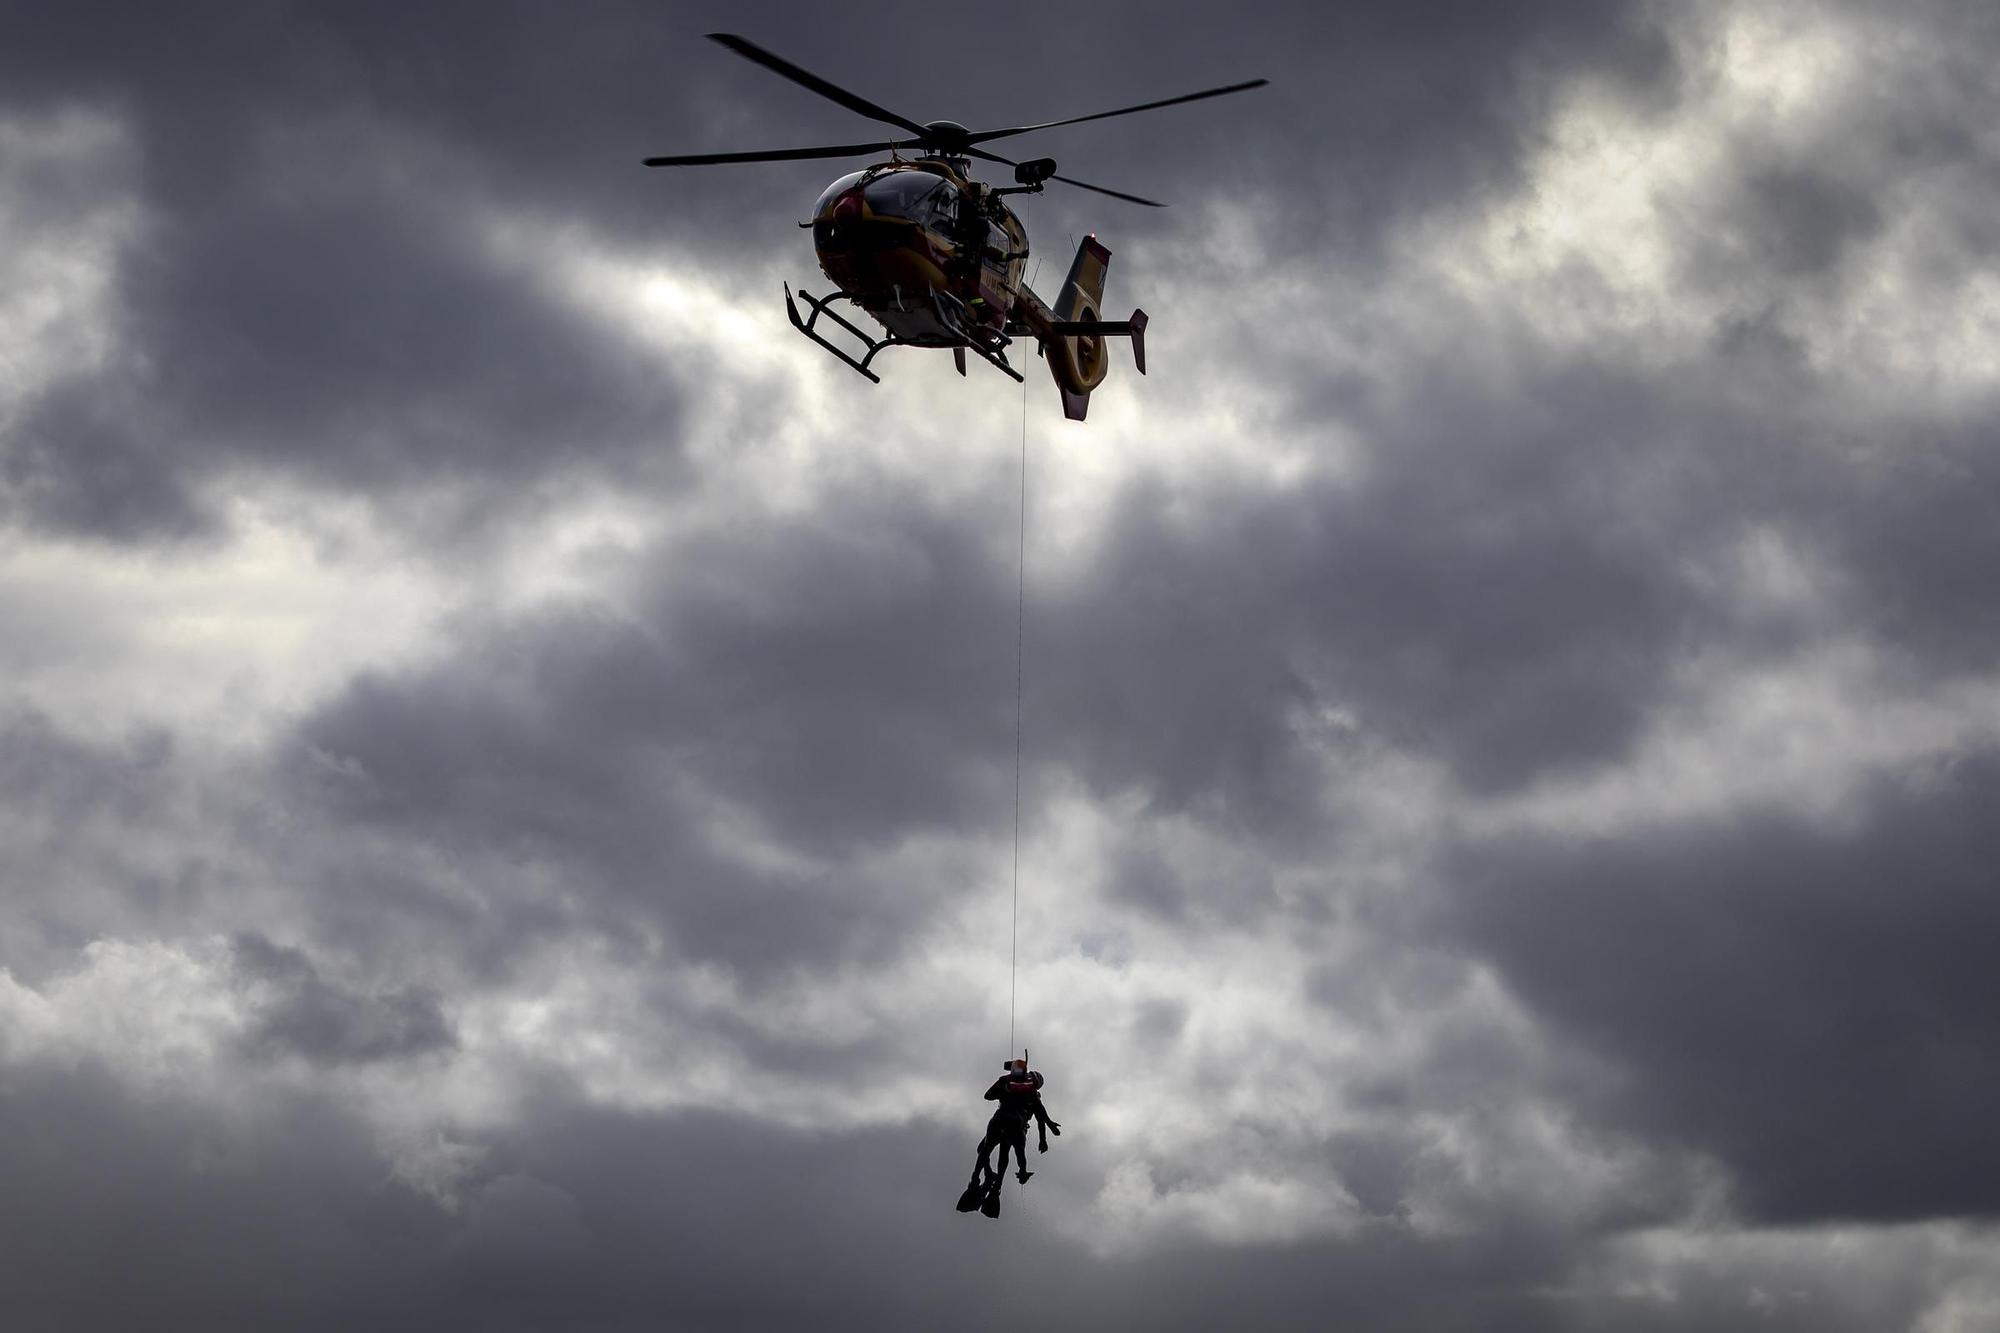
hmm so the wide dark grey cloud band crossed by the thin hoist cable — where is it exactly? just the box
[274,342,1698,971]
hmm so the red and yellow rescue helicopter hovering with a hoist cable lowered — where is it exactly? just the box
[646,32,1268,420]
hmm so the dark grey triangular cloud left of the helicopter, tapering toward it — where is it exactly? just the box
[10,116,696,536]
